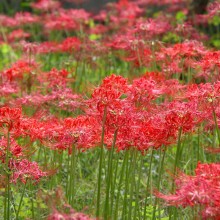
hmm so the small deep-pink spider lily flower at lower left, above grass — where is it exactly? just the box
[9,159,47,184]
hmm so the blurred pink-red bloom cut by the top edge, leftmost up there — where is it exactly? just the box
[31,0,61,11]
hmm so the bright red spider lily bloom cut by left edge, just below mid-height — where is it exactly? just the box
[0,107,22,130]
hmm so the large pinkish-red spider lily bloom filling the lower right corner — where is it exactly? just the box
[156,162,220,220]
